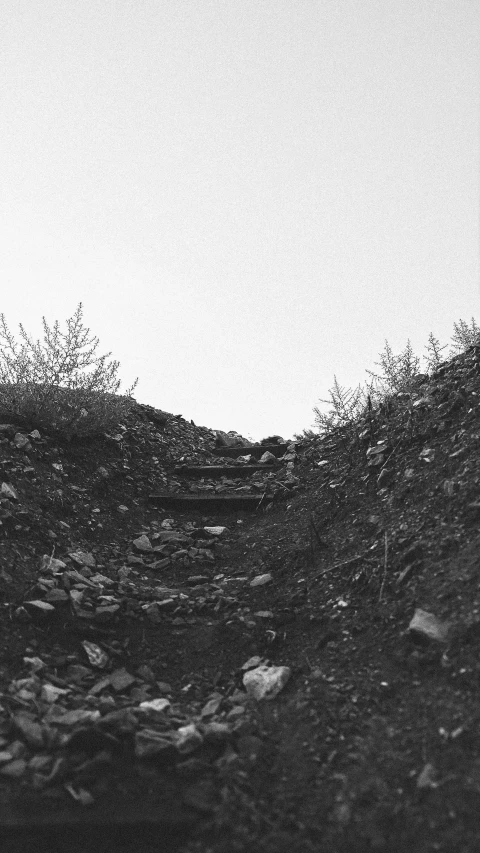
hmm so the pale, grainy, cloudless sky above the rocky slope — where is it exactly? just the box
[0,0,480,440]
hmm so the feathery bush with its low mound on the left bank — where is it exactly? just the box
[0,302,138,440]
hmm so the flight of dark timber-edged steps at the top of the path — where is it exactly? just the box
[150,444,289,514]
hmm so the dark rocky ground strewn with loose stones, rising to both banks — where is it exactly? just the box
[0,347,480,853]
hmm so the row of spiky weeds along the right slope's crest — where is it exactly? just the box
[310,317,480,437]
